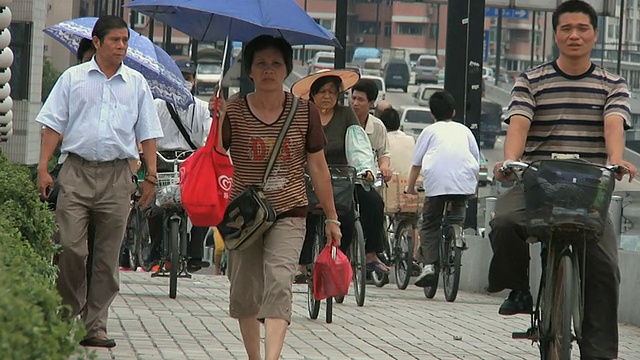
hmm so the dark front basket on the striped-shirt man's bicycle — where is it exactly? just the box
[522,160,615,241]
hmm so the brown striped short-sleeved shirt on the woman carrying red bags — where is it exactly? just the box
[223,93,325,217]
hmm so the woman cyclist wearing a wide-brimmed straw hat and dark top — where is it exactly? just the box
[291,70,389,276]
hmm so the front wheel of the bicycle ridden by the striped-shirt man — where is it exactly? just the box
[540,255,575,360]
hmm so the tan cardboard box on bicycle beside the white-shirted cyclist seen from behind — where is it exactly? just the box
[382,173,425,213]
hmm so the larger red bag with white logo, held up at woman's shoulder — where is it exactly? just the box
[180,99,233,226]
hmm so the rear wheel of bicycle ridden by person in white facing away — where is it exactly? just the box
[440,225,462,302]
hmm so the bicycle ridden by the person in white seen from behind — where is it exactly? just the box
[418,188,469,302]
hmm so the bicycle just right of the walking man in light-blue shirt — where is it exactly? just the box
[151,150,193,299]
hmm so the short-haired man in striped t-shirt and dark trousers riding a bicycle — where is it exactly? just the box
[488,0,637,359]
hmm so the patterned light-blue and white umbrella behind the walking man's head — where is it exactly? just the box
[44,17,193,108]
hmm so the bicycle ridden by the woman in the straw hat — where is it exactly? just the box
[307,165,367,310]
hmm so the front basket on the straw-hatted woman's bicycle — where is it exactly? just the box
[306,165,356,213]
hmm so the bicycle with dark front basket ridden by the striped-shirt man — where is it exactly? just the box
[501,160,626,360]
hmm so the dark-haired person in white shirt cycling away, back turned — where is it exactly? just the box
[407,91,480,287]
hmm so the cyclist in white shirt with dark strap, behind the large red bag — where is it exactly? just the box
[147,60,212,272]
